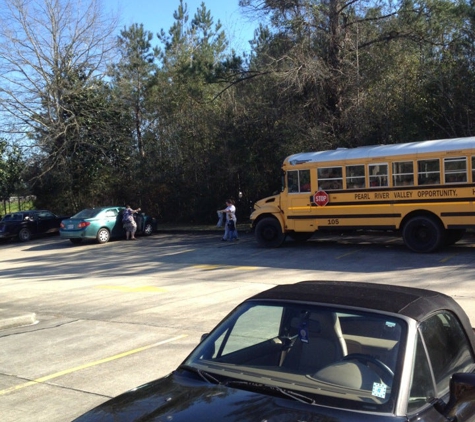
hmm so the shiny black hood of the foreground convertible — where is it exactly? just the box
[74,372,398,422]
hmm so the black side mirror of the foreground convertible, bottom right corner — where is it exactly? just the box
[443,373,475,420]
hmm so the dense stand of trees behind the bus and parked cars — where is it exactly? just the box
[0,0,475,223]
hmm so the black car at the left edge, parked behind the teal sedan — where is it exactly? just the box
[0,210,68,242]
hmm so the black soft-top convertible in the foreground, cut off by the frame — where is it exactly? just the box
[71,281,475,422]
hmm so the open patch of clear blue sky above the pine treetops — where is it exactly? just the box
[103,0,257,54]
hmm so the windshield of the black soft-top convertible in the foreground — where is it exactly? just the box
[184,301,407,412]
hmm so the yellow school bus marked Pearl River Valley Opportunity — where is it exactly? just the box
[251,137,475,253]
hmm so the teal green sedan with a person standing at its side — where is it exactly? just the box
[59,206,157,243]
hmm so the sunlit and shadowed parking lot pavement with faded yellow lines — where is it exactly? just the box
[0,232,475,422]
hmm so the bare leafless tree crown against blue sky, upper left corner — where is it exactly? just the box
[0,0,117,143]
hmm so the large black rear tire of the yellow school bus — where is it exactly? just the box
[402,215,445,253]
